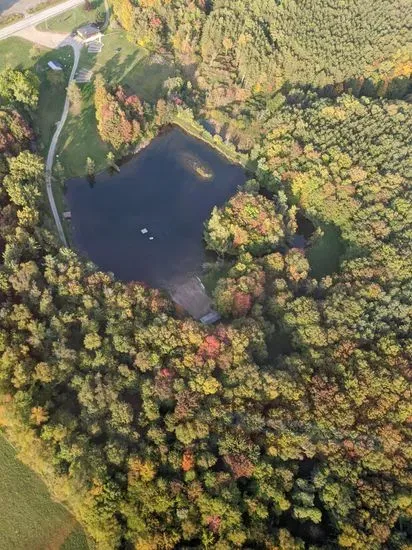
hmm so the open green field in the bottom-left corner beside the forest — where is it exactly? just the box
[0,434,88,550]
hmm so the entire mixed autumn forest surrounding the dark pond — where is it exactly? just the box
[0,0,412,550]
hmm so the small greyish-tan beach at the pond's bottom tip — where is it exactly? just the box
[169,277,220,324]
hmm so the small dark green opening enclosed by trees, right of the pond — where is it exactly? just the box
[307,225,345,279]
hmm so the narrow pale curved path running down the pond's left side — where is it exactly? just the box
[46,38,82,246]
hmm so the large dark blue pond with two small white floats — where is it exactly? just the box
[67,128,246,288]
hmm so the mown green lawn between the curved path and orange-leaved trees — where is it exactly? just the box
[58,31,175,177]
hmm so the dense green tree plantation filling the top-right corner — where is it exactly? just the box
[113,0,412,107]
